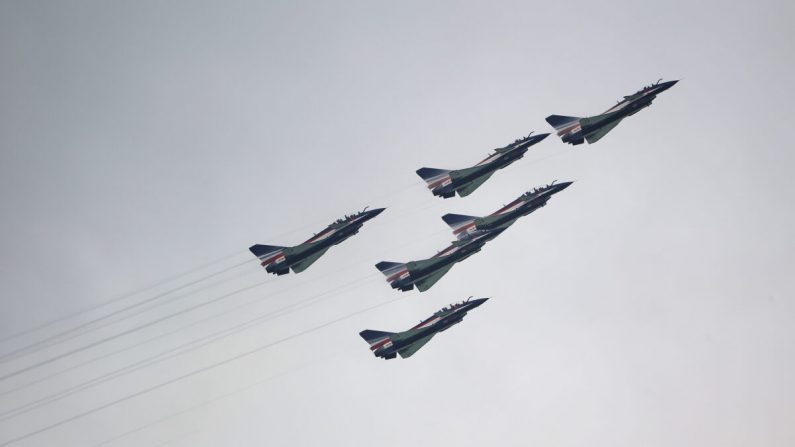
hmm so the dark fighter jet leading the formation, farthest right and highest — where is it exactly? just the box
[547,79,679,145]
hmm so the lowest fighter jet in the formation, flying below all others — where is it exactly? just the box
[359,298,488,360]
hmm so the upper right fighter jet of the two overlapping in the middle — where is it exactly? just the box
[442,182,572,239]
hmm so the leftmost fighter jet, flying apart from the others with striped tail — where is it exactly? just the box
[249,208,384,276]
